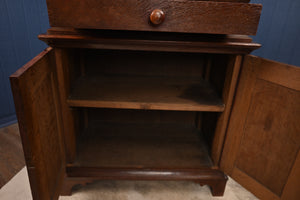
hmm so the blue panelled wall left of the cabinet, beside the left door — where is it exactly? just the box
[0,0,49,127]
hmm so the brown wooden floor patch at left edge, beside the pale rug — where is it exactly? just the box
[0,124,25,188]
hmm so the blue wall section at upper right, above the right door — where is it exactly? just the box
[251,0,300,66]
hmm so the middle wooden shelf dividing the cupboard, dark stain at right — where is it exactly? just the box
[67,76,225,112]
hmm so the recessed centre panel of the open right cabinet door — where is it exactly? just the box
[236,80,300,196]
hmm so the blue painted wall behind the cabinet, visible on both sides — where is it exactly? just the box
[0,0,300,127]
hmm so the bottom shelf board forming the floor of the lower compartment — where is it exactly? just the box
[72,122,212,169]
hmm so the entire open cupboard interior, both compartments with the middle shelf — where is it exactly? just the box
[62,49,235,168]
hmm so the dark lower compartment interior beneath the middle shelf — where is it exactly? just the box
[73,108,217,169]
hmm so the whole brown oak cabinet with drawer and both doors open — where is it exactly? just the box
[10,0,300,199]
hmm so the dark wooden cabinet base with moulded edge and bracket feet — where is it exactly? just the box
[60,167,228,196]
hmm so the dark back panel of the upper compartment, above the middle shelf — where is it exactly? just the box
[84,50,205,77]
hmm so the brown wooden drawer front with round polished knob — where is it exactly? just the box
[47,0,261,35]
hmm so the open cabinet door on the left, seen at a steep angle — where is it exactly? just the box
[10,48,65,200]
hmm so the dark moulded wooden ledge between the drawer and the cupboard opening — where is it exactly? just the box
[39,28,261,54]
